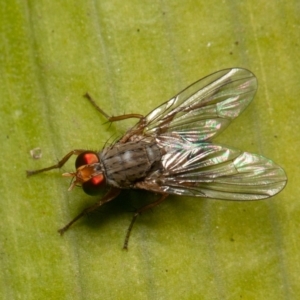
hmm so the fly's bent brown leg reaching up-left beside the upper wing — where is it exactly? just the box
[84,93,146,143]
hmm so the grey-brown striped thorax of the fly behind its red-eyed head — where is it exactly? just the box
[99,141,162,188]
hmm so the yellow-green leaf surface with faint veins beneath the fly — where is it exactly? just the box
[0,0,300,300]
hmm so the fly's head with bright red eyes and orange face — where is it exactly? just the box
[63,151,105,196]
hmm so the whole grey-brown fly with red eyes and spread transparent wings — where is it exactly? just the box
[27,68,287,249]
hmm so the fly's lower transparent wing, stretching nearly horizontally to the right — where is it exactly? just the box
[146,142,287,200]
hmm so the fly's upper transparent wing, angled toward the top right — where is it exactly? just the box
[144,68,257,142]
